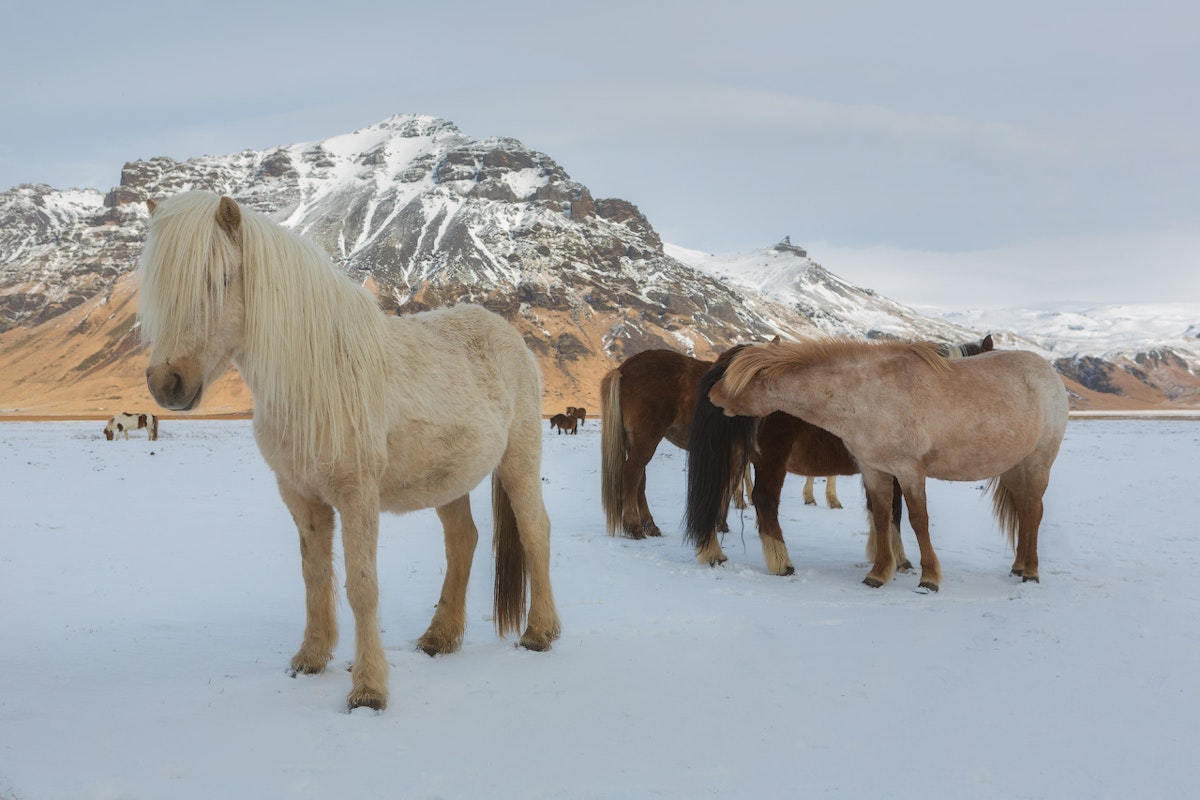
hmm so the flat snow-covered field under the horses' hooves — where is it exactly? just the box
[0,420,1200,800]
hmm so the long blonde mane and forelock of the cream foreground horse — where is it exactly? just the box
[142,192,386,473]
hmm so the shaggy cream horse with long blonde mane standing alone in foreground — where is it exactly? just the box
[139,192,559,709]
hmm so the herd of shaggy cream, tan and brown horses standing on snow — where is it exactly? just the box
[133,192,1067,710]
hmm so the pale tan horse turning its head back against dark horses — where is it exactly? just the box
[708,339,1068,591]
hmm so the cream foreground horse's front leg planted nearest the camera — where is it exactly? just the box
[337,480,388,710]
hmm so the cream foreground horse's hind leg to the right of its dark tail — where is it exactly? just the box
[493,431,562,650]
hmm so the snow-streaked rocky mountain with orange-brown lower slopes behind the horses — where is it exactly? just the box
[0,116,1196,416]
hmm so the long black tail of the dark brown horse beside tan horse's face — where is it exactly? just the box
[683,347,758,552]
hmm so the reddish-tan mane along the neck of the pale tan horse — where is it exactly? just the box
[725,337,950,397]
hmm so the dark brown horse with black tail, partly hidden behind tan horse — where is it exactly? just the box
[684,336,992,575]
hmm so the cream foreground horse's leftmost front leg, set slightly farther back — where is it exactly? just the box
[278,481,337,675]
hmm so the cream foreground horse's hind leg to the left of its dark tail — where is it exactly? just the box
[416,494,479,656]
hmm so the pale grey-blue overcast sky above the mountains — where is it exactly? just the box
[0,0,1200,308]
